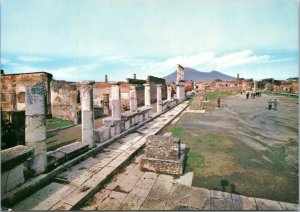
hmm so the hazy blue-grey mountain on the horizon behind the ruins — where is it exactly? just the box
[163,68,236,82]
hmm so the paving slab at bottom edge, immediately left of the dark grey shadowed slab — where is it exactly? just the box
[189,187,210,210]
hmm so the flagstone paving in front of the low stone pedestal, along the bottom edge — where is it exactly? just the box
[80,155,298,211]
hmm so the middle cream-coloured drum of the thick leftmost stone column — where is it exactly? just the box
[25,115,46,143]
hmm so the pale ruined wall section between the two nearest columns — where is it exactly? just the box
[51,80,80,122]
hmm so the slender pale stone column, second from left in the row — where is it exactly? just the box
[80,80,95,148]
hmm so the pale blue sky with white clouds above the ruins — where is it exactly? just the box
[1,0,299,81]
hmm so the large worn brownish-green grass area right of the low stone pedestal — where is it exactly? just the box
[164,125,298,203]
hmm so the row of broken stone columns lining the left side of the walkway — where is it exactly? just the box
[25,80,184,174]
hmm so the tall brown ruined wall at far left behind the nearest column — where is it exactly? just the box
[1,72,52,114]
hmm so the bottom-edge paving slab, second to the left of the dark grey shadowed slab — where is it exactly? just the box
[164,184,191,210]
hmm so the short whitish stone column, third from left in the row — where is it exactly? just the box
[111,82,121,120]
